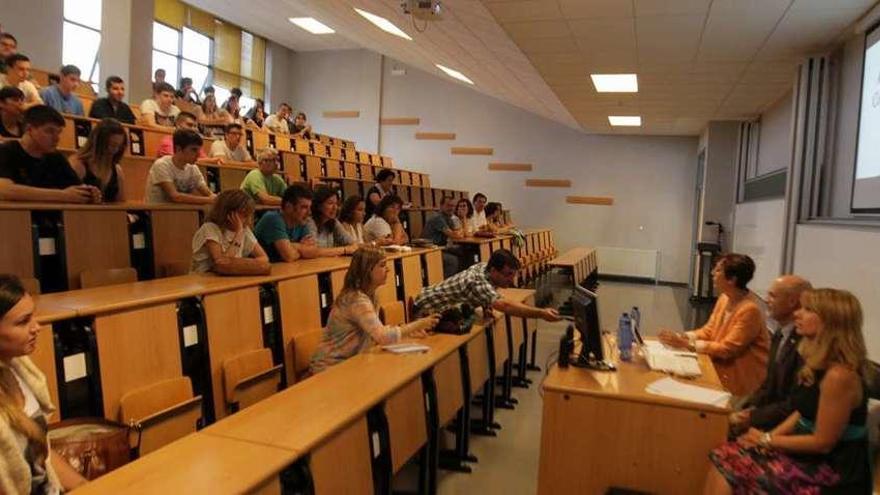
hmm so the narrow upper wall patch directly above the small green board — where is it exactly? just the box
[758,92,792,176]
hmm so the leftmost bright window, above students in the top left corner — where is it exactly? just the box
[61,0,102,91]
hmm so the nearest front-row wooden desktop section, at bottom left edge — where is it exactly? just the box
[72,432,299,495]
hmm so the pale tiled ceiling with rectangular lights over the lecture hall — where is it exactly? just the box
[186,0,876,135]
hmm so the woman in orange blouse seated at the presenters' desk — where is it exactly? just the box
[660,254,770,396]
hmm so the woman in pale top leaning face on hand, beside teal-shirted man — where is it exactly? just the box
[190,189,271,275]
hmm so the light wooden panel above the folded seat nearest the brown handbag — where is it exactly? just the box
[95,303,183,420]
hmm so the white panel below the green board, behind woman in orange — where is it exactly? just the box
[732,198,785,296]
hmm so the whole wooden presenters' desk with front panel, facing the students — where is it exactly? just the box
[538,355,730,495]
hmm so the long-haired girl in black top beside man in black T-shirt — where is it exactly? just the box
[70,119,128,203]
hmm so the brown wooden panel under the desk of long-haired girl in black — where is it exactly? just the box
[63,210,131,289]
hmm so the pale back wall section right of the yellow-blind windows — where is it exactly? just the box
[288,50,382,151]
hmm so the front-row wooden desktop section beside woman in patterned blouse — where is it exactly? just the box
[202,325,483,452]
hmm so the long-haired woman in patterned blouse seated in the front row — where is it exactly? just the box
[310,246,439,374]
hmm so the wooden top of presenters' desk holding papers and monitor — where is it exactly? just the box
[543,351,729,412]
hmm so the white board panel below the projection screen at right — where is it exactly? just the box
[794,225,880,360]
